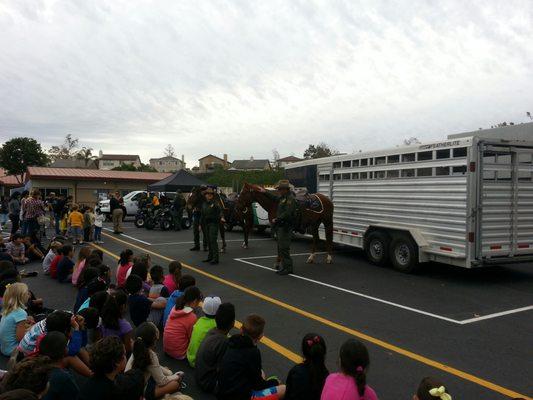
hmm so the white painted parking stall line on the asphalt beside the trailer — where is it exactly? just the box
[234,253,533,325]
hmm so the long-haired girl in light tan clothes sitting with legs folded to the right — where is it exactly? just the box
[126,322,182,400]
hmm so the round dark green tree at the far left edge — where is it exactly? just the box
[0,137,50,183]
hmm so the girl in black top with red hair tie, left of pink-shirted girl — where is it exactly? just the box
[285,333,329,400]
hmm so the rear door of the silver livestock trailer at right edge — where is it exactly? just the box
[477,143,533,262]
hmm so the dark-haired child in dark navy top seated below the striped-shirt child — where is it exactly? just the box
[39,331,80,400]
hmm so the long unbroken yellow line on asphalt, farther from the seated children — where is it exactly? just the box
[98,233,533,400]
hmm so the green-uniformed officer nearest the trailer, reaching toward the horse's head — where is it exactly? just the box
[262,179,297,275]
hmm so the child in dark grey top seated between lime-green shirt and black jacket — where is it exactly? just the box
[194,303,235,393]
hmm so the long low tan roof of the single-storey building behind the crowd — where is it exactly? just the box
[25,167,171,183]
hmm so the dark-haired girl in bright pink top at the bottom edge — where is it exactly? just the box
[321,339,378,400]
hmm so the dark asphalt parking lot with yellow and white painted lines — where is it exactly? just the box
[2,222,533,400]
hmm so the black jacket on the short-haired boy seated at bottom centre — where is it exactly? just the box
[217,334,278,400]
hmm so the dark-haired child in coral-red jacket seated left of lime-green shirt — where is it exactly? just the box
[163,286,202,360]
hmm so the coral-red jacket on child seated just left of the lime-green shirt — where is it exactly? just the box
[163,307,197,360]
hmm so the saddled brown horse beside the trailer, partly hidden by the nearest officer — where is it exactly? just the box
[237,183,333,264]
